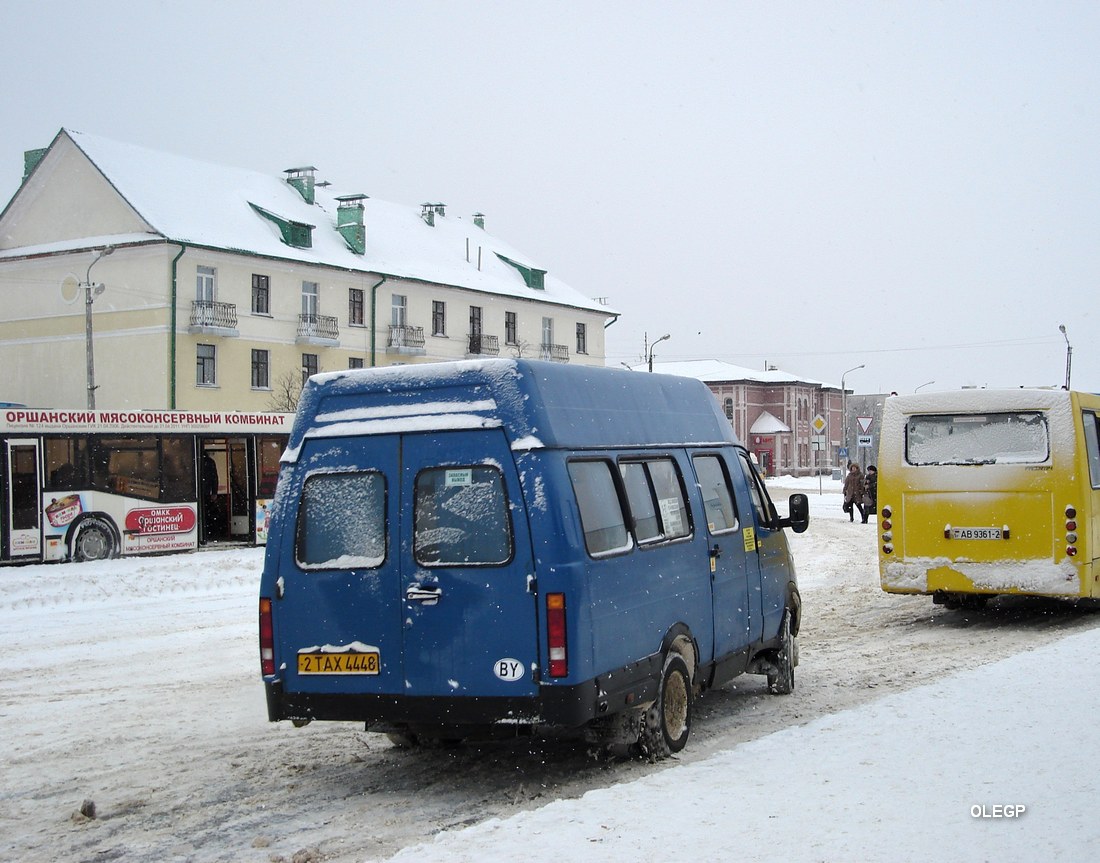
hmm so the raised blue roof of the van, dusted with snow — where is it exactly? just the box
[288,359,736,461]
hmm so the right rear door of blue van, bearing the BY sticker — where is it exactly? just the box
[399,429,538,697]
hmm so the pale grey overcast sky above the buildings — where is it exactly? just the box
[0,0,1100,392]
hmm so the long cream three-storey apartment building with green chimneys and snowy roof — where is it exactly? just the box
[0,129,617,411]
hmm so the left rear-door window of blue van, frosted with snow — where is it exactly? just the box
[295,471,386,569]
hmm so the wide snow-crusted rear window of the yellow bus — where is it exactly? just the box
[905,411,1051,465]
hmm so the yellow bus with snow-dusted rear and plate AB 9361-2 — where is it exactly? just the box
[878,389,1100,608]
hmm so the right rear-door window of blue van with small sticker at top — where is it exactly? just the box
[413,465,512,566]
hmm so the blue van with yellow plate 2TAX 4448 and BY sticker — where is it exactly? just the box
[260,359,809,759]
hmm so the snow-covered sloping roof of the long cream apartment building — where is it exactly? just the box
[23,130,618,317]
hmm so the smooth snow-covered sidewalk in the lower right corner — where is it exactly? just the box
[392,630,1100,863]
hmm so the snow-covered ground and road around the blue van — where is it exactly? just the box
[0,477,1100,863]
